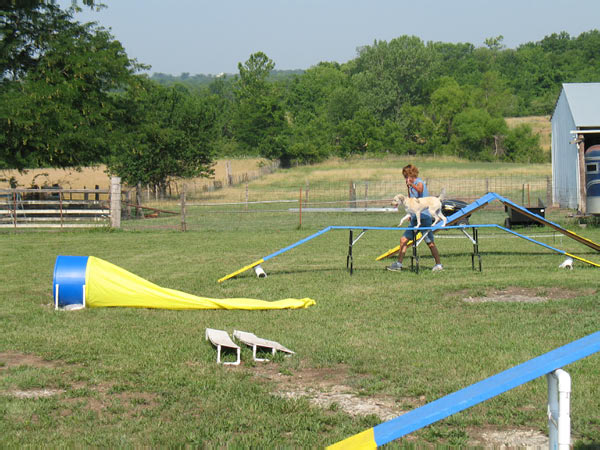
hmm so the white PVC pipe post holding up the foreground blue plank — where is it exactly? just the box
[546,369,571,450]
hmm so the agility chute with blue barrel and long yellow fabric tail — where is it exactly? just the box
[53,255,315,310]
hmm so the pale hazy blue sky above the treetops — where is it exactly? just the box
[58,0,600,75]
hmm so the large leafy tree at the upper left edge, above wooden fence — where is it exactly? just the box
[0,4,142,169]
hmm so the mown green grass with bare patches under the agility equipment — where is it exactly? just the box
[0,157,600,448]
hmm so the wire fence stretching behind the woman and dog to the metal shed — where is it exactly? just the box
[119,176,552,230]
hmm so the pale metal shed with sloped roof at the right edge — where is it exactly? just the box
[551,83,600,213]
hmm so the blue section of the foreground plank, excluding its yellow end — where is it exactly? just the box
[373,331,600,446]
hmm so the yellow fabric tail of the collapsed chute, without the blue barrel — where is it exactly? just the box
[85,256,315,310]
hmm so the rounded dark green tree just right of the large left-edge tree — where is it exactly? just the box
[108,78,217,193]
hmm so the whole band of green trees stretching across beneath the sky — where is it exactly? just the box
[0,1,600,192]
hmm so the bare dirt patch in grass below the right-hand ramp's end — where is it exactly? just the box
[458,286,596,303]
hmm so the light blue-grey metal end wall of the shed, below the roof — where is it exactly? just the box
[552,90,579,209]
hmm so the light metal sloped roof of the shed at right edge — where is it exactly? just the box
[563,83,600,128]
